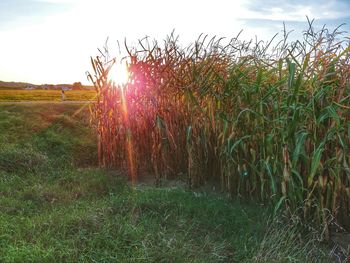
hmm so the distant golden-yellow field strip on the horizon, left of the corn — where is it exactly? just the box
[0,89,96,102]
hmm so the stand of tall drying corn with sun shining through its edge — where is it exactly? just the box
[88,22,350,233]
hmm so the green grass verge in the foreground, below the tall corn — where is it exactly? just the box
[0,104,328,262]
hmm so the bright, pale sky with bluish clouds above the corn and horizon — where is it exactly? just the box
[0,0,350,84]
